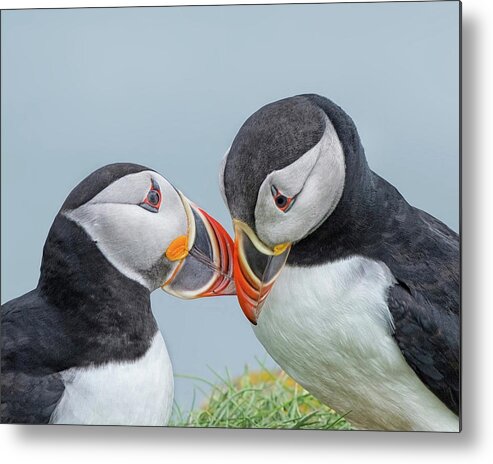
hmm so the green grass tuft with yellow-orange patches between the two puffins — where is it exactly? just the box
[169,367,351,430]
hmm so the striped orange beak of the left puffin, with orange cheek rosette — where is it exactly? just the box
[161,194,236,299]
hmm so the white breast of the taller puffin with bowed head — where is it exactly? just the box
[254,257,459,431]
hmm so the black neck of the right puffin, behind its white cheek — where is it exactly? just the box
[287,95,418,266]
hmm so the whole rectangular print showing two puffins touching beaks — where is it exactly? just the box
[1,1,461,432]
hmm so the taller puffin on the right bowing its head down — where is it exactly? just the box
[220,94,460,431]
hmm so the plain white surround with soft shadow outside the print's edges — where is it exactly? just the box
[0,0,493,464]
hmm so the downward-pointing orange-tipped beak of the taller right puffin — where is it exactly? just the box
[233,219,291,325]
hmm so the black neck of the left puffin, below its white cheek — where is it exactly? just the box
[38,214,157,365]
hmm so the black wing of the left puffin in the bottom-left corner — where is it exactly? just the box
[1,290,65,424]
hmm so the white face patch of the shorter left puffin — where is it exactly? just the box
[65,171,188,291]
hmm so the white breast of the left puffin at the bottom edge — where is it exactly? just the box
[50,332,173,425]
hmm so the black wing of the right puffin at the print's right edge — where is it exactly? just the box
[387,210,460,414]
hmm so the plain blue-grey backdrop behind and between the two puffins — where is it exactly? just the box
[1,2,459,408]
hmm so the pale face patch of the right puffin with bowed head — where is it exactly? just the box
[255,116,345,247]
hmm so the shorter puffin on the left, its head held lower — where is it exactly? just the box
[1,163,234,426]
